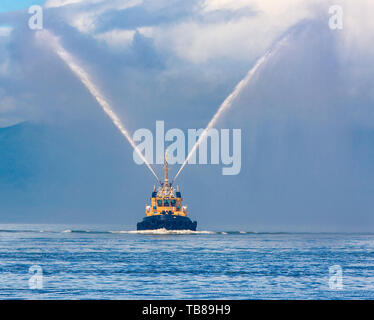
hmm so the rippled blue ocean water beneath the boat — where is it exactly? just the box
[0,225,374,299]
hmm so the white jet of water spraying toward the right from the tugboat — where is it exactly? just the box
[172,36,288,183]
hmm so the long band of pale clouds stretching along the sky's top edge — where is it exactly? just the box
[38,0,374,67]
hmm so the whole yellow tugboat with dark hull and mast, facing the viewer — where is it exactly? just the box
[137,151,197,231]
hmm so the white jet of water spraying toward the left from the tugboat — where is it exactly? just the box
[37,30,160,182]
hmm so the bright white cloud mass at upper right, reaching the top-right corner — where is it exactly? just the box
[134,0,374,63]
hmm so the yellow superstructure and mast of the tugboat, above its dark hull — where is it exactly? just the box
[145,152,187,217]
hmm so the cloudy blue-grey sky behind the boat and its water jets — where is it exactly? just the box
[0,0,374,232]
